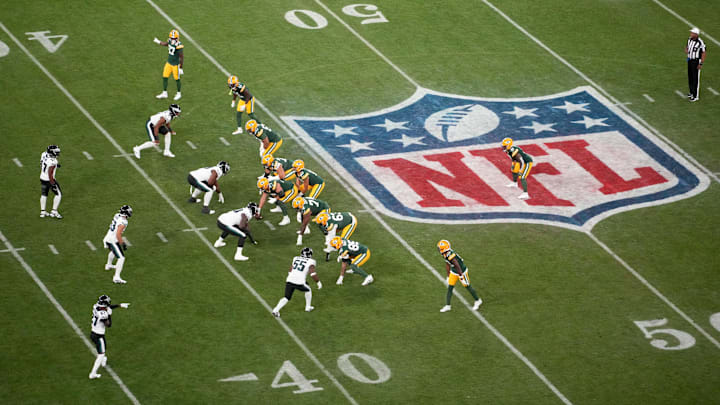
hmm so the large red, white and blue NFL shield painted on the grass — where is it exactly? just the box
[283,87,709,230]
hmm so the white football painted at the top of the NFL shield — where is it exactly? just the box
[425,104,500,142]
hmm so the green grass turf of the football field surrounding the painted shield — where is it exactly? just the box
[0,1,720,404]
